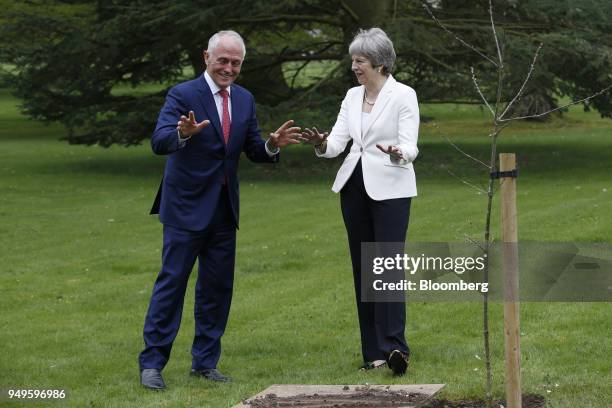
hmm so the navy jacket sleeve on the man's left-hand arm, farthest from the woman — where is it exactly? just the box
[151,87,187,154]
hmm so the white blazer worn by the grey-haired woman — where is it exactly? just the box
[316,75,419,201]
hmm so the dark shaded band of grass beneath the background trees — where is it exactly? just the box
[24,140,612,184]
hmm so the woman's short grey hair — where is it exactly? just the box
[349,27,395,75]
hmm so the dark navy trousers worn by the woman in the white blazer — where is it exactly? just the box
[340,161,411,362]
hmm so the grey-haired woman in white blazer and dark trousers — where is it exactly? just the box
[302,28,419,375]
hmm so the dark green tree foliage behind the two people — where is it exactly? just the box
[0,0,612,146]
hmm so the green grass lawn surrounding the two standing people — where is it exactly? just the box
[0,87,612,407]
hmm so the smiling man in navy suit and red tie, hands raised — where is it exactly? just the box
[139,31,300,389]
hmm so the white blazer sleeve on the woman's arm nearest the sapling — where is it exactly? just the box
[397,89,419,164]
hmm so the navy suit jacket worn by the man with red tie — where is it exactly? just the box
[151,75,279,231]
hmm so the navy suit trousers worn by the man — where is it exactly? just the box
[139,187,236,370]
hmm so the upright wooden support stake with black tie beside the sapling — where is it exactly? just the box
[499,153,522,408]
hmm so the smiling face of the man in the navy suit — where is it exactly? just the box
[204,38,243,89]
